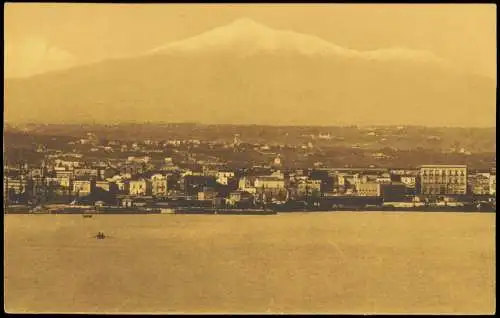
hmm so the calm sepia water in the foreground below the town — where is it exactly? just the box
[4,212,496,313]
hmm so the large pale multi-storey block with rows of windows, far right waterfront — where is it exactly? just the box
[419,165,467,195]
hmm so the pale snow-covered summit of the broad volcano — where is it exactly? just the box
[148,18,447,63]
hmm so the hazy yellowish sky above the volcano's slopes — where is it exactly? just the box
[4,3,496,78]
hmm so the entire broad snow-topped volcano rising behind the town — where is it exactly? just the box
[4,19,496,126]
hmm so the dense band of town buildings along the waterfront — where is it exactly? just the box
[4,147,496,210]
